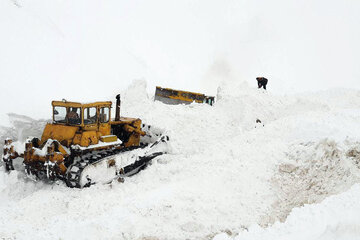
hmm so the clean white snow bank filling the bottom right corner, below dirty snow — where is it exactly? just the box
[213,184,360,240]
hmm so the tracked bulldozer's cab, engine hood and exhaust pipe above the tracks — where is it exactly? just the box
[43,99,145,147]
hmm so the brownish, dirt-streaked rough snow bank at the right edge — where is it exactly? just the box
[271,139,360,223]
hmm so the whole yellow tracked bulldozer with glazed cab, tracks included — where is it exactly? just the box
[3,95,169,188]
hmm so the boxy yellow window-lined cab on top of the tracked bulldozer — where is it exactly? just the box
[52,101,111,127]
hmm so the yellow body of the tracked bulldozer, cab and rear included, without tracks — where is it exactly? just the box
[16,101,145,174]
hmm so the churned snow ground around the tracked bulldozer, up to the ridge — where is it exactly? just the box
[0,81,360,239]
